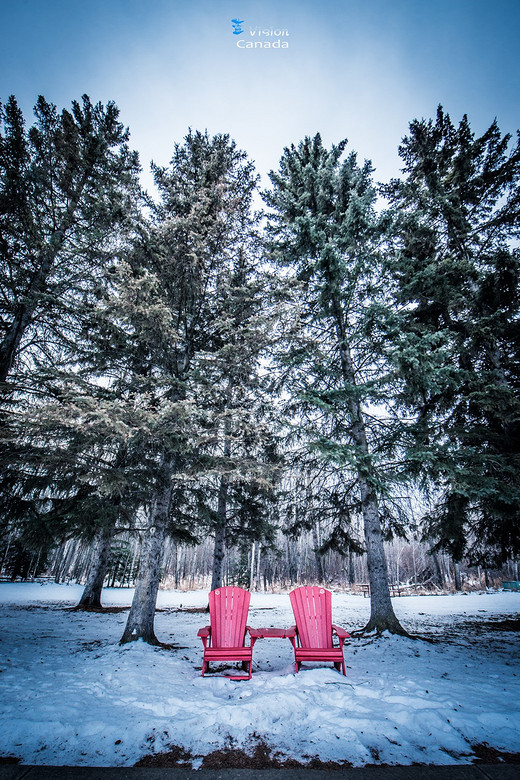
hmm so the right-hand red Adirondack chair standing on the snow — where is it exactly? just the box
[289,587,350,675]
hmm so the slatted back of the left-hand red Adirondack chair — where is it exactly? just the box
[209,586,251,648]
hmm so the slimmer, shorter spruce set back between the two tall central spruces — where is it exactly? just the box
[197,250,280,590]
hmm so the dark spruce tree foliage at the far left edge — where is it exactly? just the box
[0,95,139,592]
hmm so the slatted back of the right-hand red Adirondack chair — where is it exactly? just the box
[289,586,332,648]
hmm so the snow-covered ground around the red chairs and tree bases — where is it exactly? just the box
[0,583,520,767]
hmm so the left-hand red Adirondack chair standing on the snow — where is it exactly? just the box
[197,587,253,680]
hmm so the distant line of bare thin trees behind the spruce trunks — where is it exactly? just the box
[13,527,519,596]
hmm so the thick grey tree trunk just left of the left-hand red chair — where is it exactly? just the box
[120,461,173,645]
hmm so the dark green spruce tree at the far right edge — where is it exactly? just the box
[384,107,520,565]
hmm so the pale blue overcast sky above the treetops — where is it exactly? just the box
[0,0,520,192]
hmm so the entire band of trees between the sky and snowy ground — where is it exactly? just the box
[0,96,520,643]
